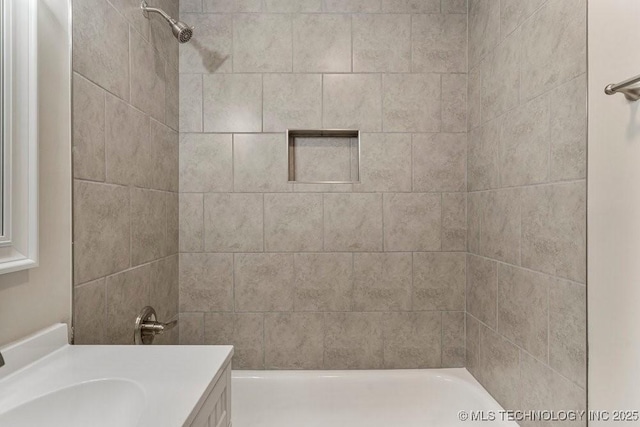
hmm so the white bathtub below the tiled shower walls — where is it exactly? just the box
[231,369,517,427]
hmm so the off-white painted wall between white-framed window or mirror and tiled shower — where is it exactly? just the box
[0,0,72,345]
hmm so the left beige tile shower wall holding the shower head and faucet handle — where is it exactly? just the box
[73,0,180,344]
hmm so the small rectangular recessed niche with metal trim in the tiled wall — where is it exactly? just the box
[287,129,360,184]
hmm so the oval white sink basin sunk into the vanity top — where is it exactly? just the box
[0,379,145,427]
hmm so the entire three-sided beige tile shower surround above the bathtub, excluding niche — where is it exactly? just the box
[69,0,586,418]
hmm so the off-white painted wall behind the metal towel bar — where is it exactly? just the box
[588,0,640,426]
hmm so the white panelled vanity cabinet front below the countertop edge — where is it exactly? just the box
[191,363,231,427]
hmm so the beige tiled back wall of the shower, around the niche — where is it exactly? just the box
[179,0,467,369]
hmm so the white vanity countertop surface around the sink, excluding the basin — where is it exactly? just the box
[0,325,233,427]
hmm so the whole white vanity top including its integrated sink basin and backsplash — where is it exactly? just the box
[0,325,233,427]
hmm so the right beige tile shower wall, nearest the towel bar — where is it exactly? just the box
[466,0,586,418]
